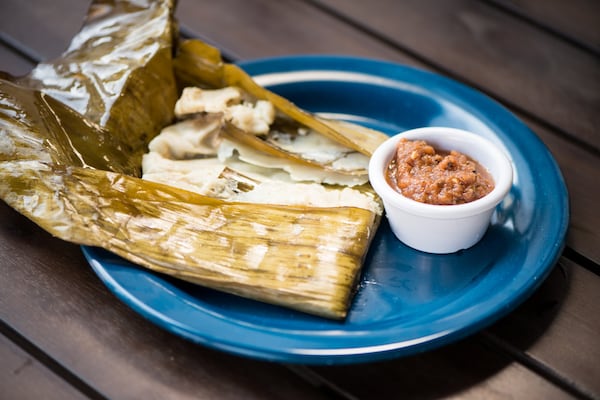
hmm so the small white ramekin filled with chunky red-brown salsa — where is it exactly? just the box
[369,127,513,254]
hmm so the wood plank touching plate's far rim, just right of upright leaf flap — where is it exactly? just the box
[176,0,422,63]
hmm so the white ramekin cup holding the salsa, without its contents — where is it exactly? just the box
[369,127,513,254]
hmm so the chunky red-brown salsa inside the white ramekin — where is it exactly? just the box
[386,139,494,205]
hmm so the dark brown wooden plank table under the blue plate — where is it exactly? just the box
[0,0,600,399]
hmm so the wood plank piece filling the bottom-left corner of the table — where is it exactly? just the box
[0,334,87,400]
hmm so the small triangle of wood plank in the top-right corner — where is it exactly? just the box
[491,0,600,52]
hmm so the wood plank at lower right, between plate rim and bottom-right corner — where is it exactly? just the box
[490,258,600,398]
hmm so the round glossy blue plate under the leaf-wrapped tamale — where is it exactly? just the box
[83,56,569,364]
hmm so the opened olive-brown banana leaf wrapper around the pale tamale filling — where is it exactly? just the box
[0,0,379,319]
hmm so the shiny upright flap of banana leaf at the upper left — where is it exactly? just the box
[17,0,178,171]
